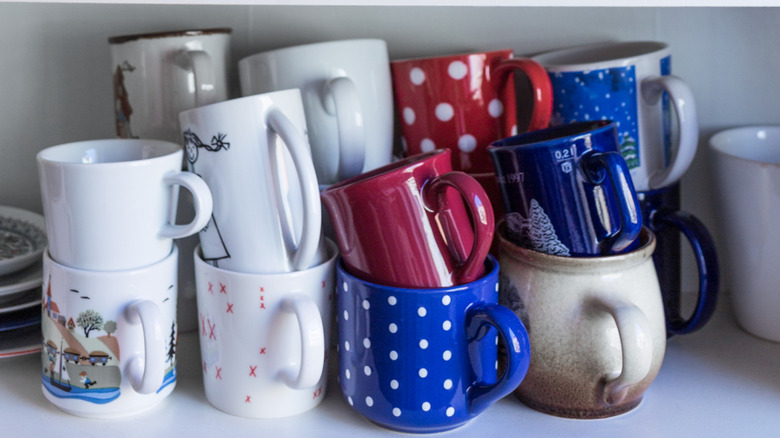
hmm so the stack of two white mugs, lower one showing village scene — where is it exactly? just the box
[37,139,212,417]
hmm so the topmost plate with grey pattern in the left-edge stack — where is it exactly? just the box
[0,205,46,275]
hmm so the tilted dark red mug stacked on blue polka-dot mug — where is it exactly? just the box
[321,149,530,432]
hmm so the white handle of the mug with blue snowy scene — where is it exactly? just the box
[641,75,699,190]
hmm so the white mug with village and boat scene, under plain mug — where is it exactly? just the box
[41,247,178,418]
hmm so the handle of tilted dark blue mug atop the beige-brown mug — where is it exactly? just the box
[580,151,642,254]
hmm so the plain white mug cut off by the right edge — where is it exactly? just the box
[709,125,780,342]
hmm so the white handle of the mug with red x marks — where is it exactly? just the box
[279,294,325,389]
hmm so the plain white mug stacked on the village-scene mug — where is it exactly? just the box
[36,139,212,271]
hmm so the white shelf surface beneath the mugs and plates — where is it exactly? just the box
[0,297,780,438]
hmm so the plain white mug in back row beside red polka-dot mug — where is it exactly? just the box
[238,39,393,185]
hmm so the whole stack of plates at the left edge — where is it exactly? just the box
[0,206,46,358]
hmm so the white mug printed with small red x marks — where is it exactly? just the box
[194,241,338,418]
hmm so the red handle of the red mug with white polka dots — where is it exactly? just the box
[494,58,553,131]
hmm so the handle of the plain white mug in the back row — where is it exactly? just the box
[322,76,366,181]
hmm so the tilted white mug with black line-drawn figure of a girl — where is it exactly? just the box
[179,90,322,274]
